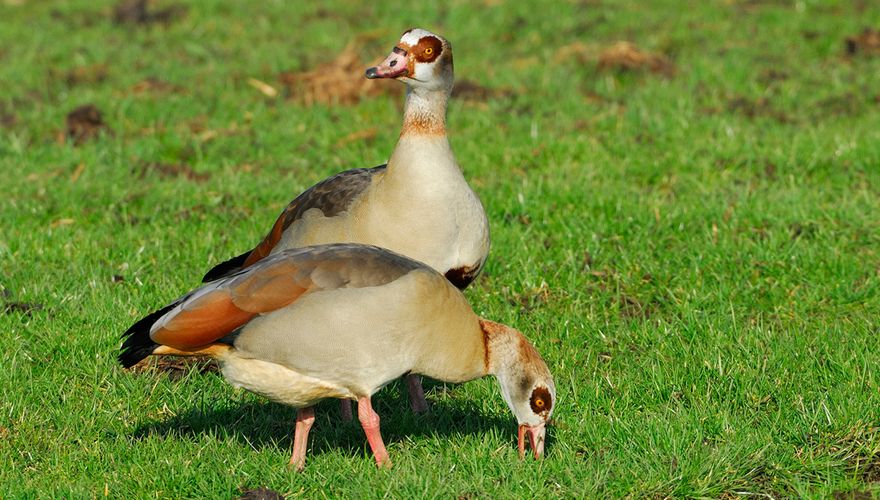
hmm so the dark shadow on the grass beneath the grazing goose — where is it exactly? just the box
[129,380,516,455]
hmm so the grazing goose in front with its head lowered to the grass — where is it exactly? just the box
[119,244,556,469]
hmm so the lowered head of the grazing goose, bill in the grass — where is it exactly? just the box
[480,319,556,458]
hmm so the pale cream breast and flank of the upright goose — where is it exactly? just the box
[273,136,489,273]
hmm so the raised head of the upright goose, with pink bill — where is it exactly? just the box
[367,28,453,92]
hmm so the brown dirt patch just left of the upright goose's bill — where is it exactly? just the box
[279,41,394,106]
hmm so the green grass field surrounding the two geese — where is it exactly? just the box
[0,0,880,498]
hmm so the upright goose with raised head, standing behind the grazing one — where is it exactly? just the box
[203,29,489,416]
